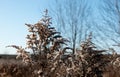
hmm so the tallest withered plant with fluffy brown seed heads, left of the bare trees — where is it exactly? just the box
[7,10,72,77]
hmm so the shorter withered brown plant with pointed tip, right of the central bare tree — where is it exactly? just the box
[76,33,108,77]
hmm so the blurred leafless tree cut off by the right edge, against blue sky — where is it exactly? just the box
[99,0,120,44]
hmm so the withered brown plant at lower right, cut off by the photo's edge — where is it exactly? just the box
[103,48,120,77]
